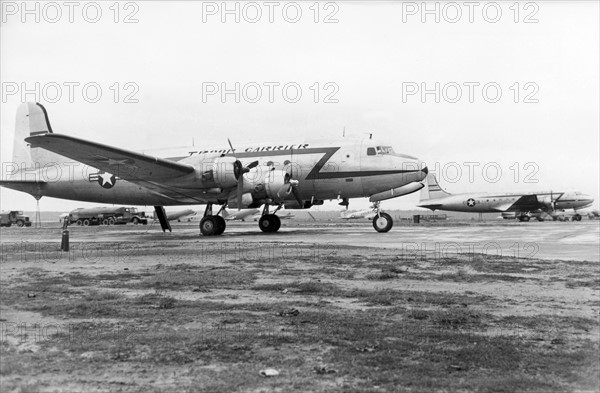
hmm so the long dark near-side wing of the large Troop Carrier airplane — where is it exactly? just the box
[25,133,194,182]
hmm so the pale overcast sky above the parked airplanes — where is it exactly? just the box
[0,1,600,211]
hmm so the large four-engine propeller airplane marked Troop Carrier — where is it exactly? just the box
[0,103,427,235]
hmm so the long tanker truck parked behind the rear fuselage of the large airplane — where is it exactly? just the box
[68,207,148,226]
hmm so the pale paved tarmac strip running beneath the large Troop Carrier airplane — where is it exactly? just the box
[1,220,600,262]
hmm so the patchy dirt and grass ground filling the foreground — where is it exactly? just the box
[0,224,600,392]
